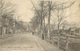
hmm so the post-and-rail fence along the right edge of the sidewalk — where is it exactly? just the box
[46,34,80,51]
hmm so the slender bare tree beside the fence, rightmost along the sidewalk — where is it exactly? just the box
[52,2,75,46]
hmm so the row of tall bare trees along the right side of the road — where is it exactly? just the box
[31,1,75,39]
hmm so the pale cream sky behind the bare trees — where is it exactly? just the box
[5,0,80,23]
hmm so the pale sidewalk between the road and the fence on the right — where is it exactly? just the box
[33,35,62,51]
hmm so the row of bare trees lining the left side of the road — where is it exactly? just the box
[0,0,24,35]
